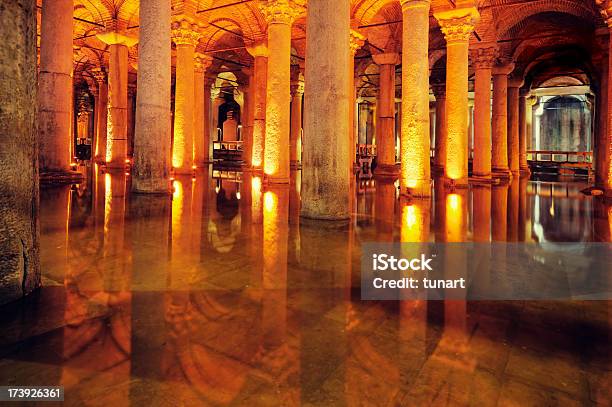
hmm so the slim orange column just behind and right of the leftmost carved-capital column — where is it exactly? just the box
[193,53,212,168]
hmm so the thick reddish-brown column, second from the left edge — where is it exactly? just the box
[38,0,74,172]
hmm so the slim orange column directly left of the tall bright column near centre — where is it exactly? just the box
[245,42,268,170]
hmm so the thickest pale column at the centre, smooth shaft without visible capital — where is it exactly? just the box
[301,0,351,220]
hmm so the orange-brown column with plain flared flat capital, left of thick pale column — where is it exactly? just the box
[97,31,138,169]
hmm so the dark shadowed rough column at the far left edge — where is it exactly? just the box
[0,0,39,306]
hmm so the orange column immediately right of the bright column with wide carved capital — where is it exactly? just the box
[472,46,496,179]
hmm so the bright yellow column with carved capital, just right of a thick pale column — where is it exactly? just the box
[172,19,200,174]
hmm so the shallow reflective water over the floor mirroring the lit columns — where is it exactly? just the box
[0,168,612,407]
